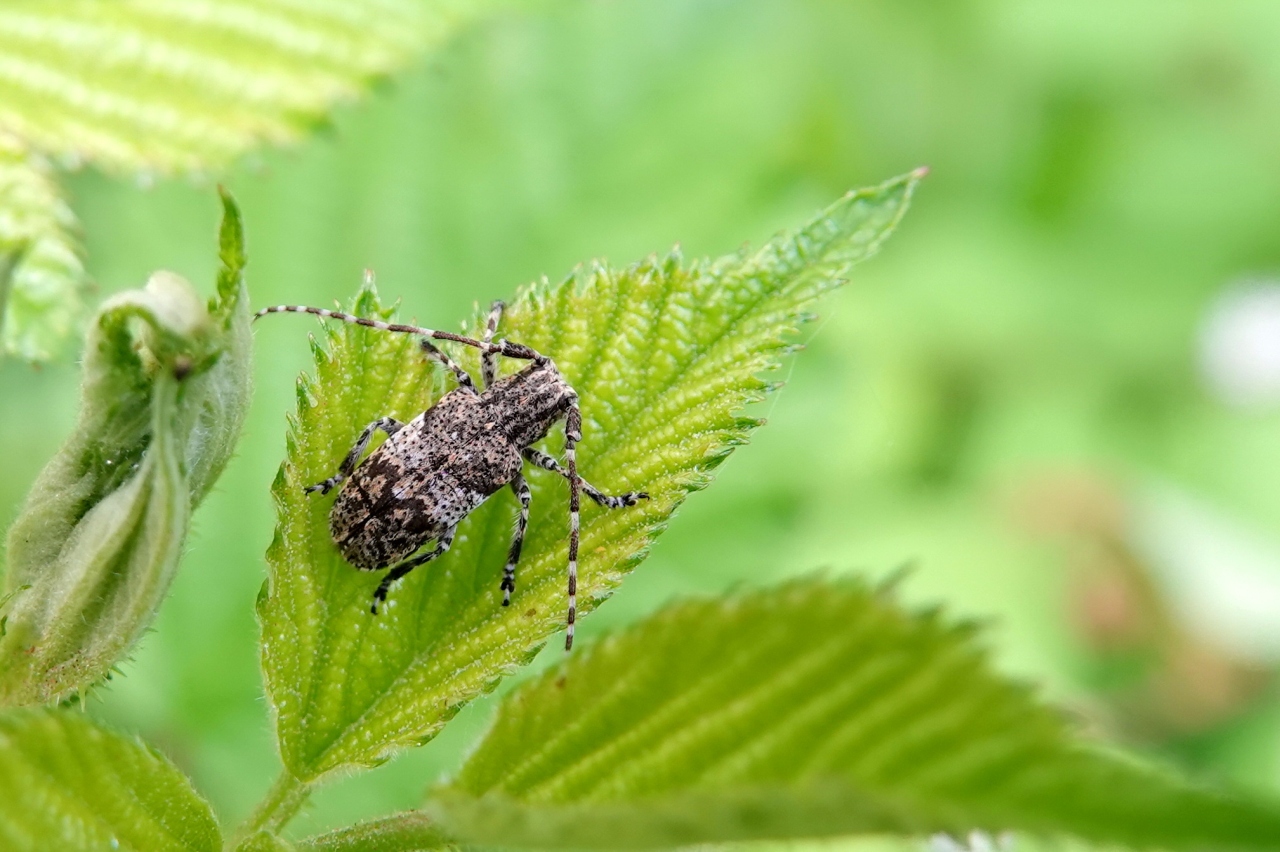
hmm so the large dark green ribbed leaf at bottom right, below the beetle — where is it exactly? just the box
[428,578,1280,849]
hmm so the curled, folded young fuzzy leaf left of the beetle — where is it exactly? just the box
[0,196,251,704]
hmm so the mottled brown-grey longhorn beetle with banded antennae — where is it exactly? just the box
[253,295,649,651]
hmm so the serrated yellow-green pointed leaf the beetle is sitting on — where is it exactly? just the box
[259,168,920,780]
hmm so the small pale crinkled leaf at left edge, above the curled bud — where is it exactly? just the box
[0,134,86,361]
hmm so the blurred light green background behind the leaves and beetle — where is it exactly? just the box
[0,0,1280,832]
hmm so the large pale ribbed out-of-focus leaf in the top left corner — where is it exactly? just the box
[0,0,476,173]
